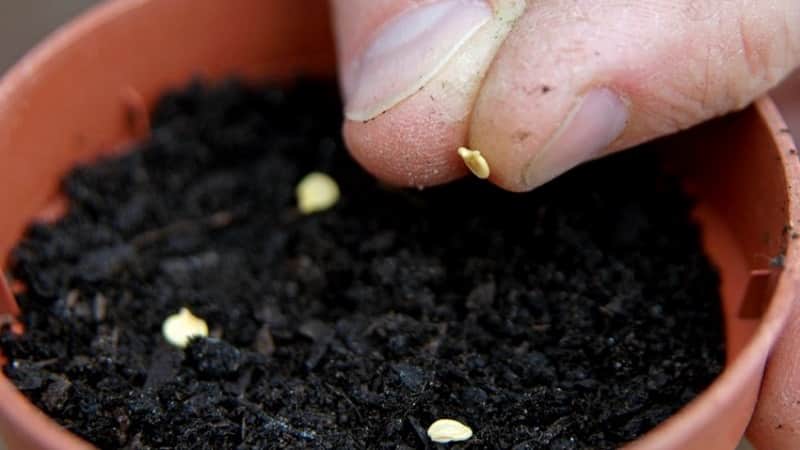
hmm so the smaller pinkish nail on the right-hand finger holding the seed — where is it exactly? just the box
[523,88,628,189]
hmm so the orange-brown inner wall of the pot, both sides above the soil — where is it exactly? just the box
[0,0,791,450]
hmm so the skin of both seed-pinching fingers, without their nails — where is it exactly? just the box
[334,0,800,190]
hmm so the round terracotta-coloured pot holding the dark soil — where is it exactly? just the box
[0,0,800,449]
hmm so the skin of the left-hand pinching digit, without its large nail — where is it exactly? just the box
[334,0,524,187]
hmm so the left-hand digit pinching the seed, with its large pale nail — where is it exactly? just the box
[332,0,525,186]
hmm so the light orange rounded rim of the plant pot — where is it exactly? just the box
[0,0,800,449]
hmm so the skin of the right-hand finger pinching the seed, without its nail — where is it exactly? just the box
[470,0,800,190]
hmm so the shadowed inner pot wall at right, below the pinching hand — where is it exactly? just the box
[659,107,788,361]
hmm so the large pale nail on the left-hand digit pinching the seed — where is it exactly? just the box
[343,0,492,121]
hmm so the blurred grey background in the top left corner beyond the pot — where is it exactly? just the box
[0,0,100,73]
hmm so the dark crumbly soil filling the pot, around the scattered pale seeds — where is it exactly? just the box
[2,82,724,449]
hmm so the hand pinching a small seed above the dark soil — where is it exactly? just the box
[332,0,800,191]
